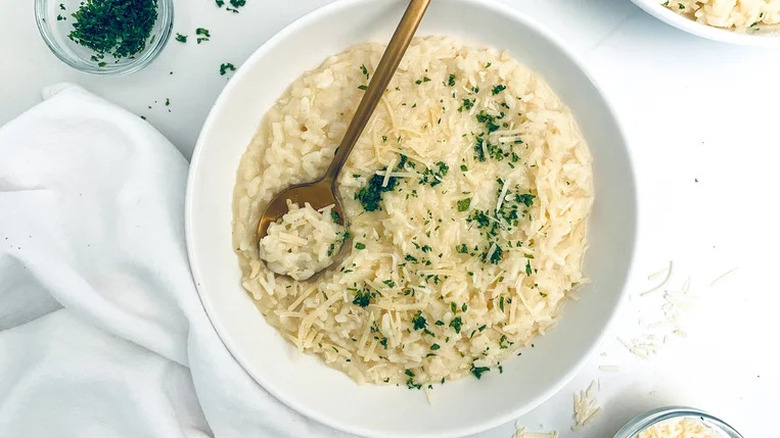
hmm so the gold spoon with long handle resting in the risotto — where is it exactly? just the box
[257,0,431,275]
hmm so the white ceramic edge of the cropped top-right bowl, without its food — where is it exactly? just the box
[631,0,780,47]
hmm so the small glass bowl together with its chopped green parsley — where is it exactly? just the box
[35,0,173,75]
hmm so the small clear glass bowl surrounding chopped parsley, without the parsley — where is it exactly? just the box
[35,0,173,76]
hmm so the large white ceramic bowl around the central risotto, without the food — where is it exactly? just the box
[186,0,636,438]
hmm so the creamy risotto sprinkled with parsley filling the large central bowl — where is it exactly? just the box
[233,37,593,388]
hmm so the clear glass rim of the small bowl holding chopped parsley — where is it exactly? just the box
[35,0,174,76]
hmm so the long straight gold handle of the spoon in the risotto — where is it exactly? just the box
[324,0,431,183]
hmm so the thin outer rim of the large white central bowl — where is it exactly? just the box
[184,0,639,438]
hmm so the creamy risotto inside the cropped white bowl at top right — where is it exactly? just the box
[661,0,780,31]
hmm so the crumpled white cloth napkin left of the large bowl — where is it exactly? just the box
[0,84,348,438]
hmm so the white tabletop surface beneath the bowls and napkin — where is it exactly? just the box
[0,0,780,438]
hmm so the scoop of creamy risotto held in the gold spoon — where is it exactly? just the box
[260,199,346,280]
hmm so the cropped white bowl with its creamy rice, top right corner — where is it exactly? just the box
[631,0,780,47]
